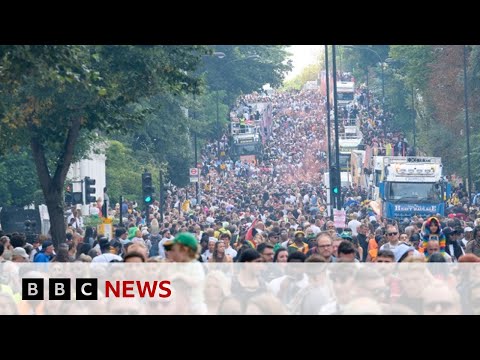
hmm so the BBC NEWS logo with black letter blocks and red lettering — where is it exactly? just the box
[22,278,172,300]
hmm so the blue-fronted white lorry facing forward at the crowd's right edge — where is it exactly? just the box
[371,156,451,220]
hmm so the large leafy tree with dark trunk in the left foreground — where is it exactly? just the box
[0,45,208,245]
